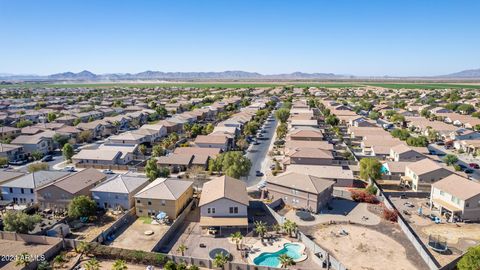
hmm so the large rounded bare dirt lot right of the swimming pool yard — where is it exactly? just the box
[313,224,419,270]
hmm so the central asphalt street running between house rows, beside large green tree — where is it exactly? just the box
[245,117,278,187]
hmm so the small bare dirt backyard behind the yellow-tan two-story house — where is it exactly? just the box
[110,218,168,251]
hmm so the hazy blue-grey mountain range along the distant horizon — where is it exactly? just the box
[0,69,480,81]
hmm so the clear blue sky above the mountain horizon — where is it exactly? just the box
[0,0,480,76]
